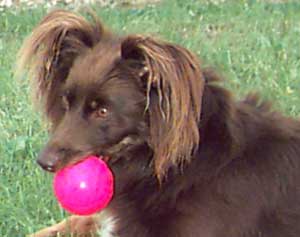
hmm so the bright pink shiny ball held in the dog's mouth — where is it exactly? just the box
[53,156,113,215]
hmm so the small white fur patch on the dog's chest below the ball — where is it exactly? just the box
[97,210,117,237]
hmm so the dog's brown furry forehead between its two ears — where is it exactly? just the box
[67,41,121,87]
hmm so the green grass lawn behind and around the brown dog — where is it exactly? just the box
[0,0,300,237]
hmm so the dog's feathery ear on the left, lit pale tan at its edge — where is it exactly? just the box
[17,10,104,122]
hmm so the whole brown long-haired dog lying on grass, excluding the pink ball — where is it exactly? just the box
[18,10,300,237]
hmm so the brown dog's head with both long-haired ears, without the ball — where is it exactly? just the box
[19,10,204,178]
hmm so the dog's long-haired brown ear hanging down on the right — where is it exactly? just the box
[121,35,204,180]
